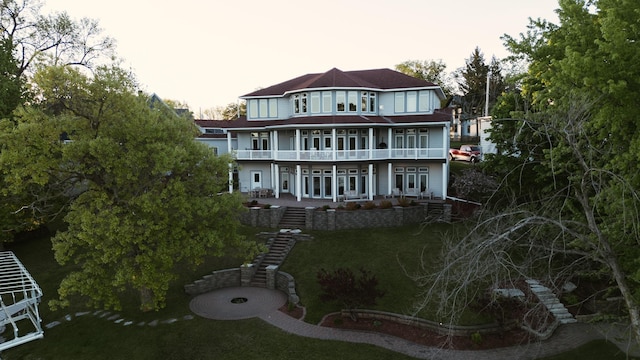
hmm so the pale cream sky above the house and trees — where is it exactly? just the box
[41,0,558,118]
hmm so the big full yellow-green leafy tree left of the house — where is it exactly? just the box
[0,66,255,310]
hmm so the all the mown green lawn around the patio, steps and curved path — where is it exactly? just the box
[2,225,632,360]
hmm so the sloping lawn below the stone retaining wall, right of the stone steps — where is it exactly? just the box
[281,225,482,323]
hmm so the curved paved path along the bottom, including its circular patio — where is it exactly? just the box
[189,287,640,360]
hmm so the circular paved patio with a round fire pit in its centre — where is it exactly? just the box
[189,287,287,320]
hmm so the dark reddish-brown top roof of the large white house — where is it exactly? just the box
[241,68,437,98]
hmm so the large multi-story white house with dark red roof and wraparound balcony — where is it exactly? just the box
[196,68,452,201]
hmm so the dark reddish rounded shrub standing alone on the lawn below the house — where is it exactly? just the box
[316,268,384,320]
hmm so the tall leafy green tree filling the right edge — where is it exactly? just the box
[452,0,640,343]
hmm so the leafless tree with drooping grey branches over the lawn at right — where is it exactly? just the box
[417,98,640,340]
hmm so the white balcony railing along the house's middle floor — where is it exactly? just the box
[235,148,448,161]
